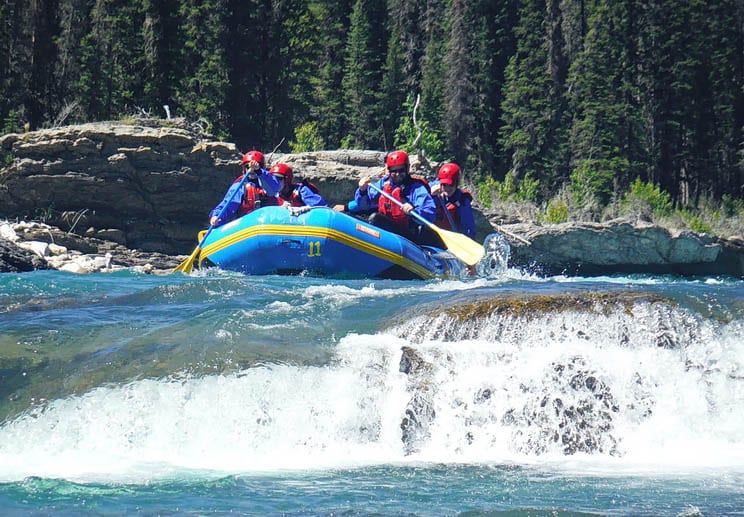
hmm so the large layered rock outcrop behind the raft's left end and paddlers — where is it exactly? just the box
[0,120,396,254]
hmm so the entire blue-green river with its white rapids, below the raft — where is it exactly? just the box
[0,264,744,516]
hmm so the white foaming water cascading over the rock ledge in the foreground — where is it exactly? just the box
[0,308,744,482]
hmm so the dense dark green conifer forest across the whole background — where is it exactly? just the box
[0,0,744,220]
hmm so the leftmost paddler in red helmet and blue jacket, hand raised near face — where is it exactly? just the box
[209,151,282,226]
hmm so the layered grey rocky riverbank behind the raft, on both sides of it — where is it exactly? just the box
[0,119,744,277]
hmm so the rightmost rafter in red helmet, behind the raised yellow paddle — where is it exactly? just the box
[431,163,476,239]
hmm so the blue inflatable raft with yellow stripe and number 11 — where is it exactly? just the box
[199,206,466,279]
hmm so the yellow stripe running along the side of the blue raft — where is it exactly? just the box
[199,224,435,278]
